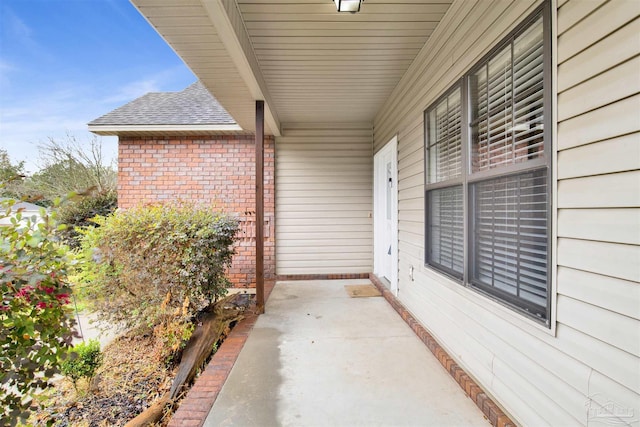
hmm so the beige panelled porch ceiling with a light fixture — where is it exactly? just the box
[131,0,453,135]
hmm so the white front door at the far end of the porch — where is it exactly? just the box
[373,137,398,294]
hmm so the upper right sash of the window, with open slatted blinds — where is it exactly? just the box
[468,16,544,172]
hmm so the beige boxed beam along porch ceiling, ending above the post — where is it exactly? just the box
[202,0,281,136]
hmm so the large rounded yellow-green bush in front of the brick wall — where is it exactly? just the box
[81,204,238,327]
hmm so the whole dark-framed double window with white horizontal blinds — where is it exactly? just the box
[425,2,551,324]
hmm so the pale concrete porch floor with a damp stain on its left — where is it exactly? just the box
[204,280,488,426]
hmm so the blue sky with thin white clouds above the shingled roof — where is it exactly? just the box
[0,0,196,172]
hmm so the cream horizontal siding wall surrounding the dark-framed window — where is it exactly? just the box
[374,0,640,425]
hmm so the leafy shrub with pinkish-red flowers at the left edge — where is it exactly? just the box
[0,199,73,425]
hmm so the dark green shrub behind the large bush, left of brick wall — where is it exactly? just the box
[58,191,118,249]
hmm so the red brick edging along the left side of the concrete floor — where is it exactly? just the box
[168,281,275,427]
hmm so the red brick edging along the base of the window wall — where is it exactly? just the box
[369,274,515,427]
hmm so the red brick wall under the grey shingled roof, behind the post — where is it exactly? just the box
[118,135,276,287]
